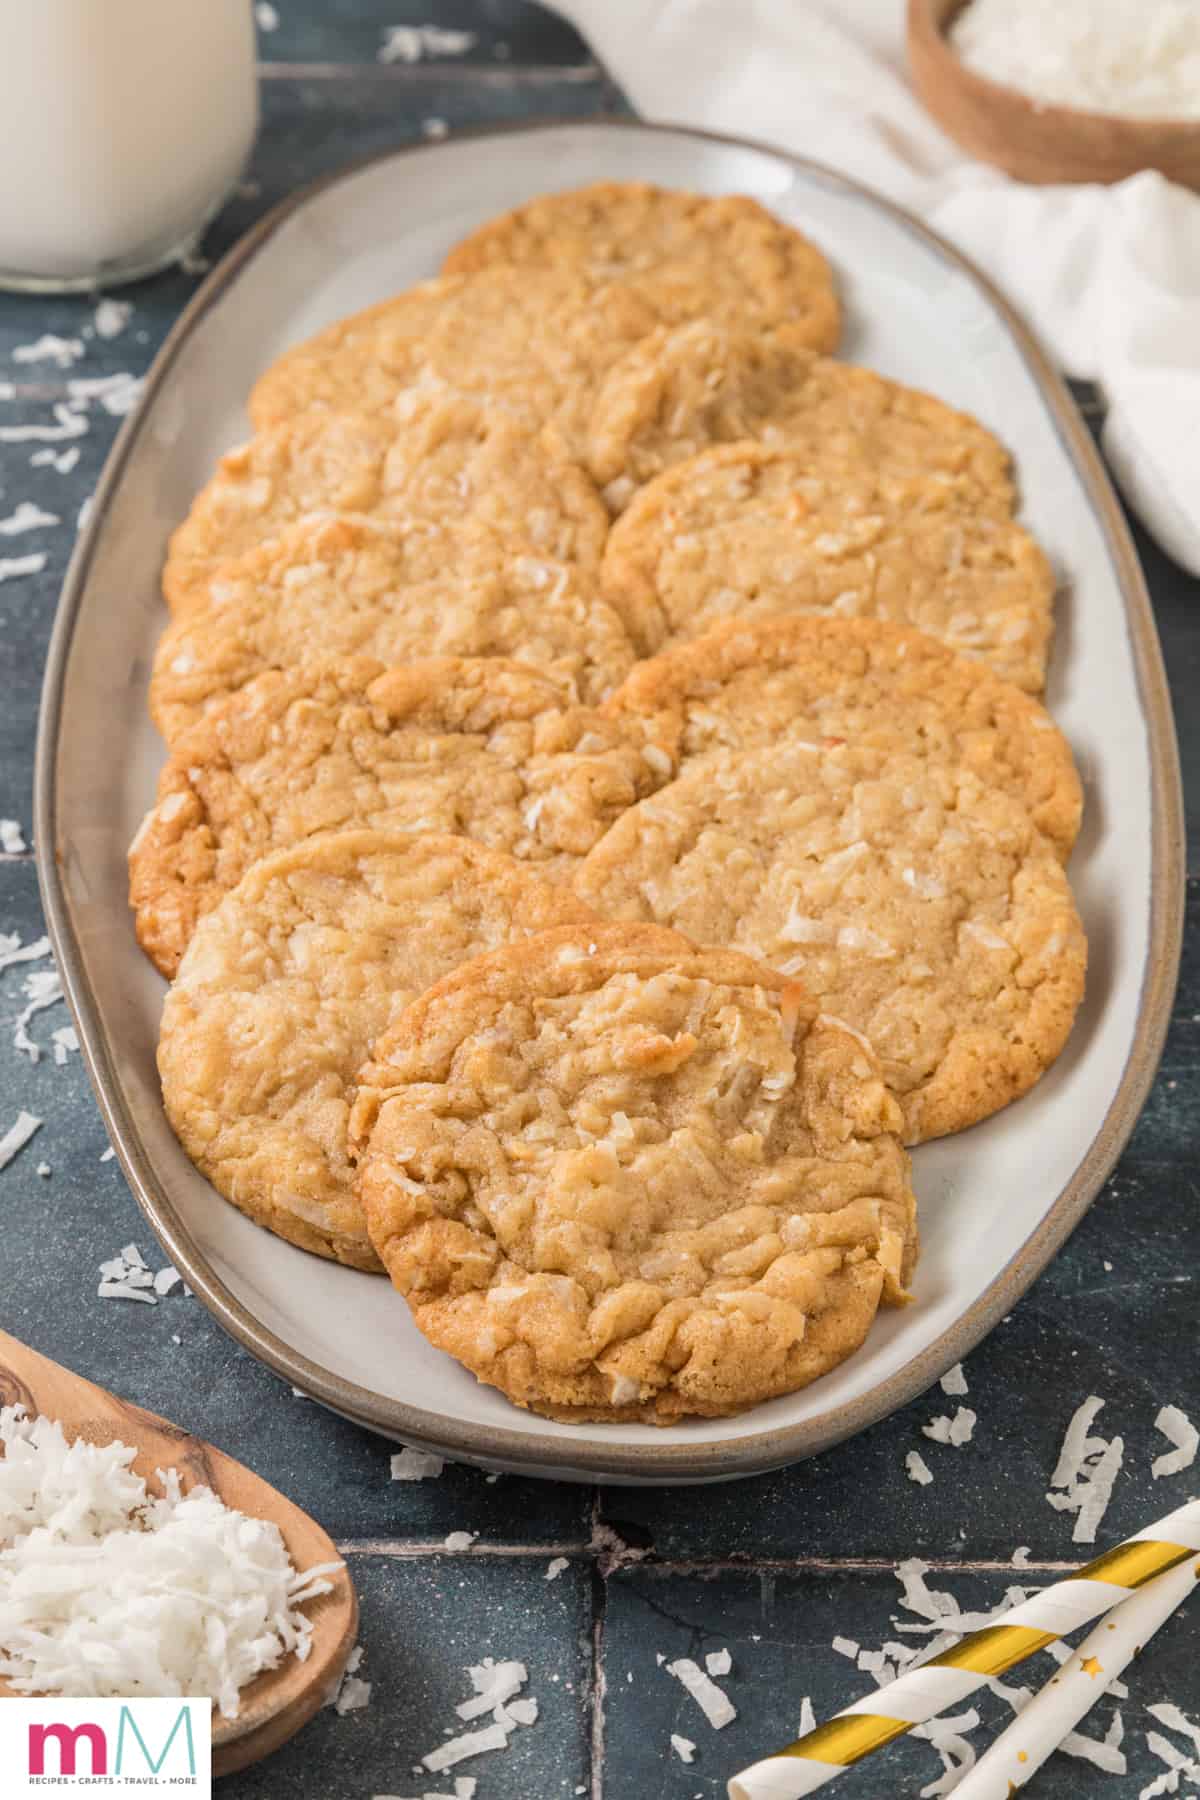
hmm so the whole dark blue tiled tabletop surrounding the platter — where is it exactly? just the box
[0,0,1200,1800]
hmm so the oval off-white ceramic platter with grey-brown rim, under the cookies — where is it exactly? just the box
[36,122,1184,1481]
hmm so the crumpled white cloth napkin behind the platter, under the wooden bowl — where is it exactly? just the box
[554,0,1200,574]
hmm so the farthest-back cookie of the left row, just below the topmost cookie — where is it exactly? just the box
[248,268,660,450]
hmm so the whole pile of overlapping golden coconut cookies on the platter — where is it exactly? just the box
[130,184,1087,1424]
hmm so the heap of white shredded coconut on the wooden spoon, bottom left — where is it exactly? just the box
[0,1406,344,1719]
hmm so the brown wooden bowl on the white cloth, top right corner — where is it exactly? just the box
[909,0,1200,189]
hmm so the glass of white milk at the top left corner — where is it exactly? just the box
[0,0,259,292]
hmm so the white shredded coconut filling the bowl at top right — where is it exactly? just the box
[950,0,1200,119]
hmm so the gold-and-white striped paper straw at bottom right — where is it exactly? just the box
[727,1501,1200,1800]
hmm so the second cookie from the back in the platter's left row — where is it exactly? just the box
[162,391,608,612]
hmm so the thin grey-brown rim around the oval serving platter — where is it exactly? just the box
[34,119,1186,1481]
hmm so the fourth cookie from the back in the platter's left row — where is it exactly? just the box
[130,657,671,976]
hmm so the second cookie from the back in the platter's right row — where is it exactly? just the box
[603,445,1054,693]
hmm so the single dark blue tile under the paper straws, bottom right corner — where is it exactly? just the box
[603,1566,1200,1800]
